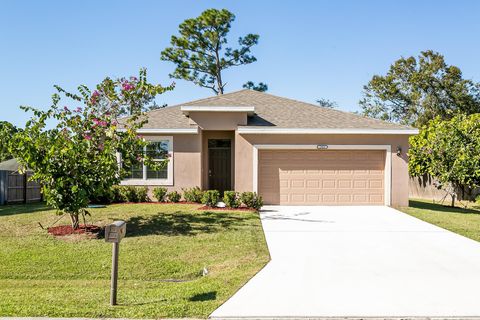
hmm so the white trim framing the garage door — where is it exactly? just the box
[253,144,392,206]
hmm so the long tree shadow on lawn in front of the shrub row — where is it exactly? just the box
[126,211,255,237]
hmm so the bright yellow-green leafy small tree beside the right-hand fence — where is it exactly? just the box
[408,114,480,206]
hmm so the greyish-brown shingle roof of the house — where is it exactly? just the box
[139,89,411,129]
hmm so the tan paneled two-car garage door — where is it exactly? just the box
[258,150,385,205]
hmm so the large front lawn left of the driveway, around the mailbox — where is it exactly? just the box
[0,204,269,318]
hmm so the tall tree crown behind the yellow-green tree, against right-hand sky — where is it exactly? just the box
[360,50,480,127]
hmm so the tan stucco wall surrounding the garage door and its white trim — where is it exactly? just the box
[235,133,409,207]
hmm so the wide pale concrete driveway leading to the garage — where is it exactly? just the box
[211,206,480,318]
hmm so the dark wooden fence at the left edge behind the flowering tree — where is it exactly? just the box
[0,171,42,205]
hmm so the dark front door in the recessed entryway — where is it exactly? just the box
[208,139,232,192]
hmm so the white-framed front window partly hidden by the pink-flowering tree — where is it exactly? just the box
[122,137,173,185]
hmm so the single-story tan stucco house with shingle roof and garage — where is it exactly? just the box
[122,90,417,206]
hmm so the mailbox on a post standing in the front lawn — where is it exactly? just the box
[105,221,127,306]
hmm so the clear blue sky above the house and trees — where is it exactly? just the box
[0,0,480,125]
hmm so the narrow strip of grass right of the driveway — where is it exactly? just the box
[400,199,480,241]
